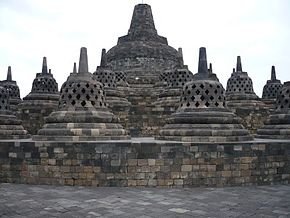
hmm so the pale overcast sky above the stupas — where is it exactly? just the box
[0,0,290,97]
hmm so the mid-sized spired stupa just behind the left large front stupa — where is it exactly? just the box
[18,57,59,134]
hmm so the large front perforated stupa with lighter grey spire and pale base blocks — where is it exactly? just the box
[33,48,130,141]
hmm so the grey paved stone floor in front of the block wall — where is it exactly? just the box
[0,184,290,218]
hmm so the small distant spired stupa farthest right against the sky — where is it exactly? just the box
[262,66,283,109]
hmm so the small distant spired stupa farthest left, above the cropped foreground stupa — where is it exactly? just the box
[0,66,21,112]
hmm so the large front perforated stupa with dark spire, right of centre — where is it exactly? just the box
[156,48,252,142]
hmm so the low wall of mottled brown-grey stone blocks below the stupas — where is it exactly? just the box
[0,139,290,187]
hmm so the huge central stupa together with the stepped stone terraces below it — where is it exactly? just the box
[106,4,179,136]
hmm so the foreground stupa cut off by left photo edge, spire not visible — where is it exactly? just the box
[0,86,30,139]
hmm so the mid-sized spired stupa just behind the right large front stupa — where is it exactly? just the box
[226,56,269,134]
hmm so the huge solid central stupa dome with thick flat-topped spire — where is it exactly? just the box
[107,4,178,83]
